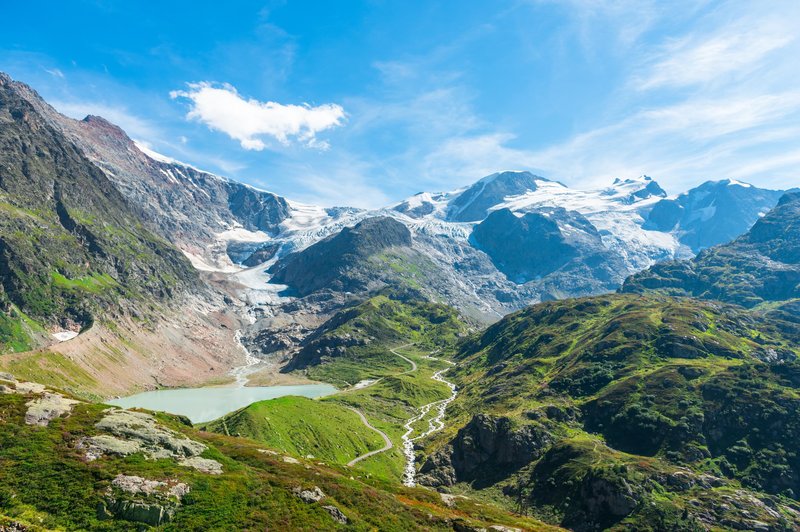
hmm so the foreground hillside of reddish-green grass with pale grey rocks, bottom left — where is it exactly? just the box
[0,375,552,530]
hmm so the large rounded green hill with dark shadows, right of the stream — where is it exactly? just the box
[418,294,800,530]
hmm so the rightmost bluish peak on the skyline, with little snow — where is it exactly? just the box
[644,179,783,253]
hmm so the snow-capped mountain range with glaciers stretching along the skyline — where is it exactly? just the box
[9,72,779,318]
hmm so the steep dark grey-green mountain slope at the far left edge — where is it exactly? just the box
[0,75,197,351]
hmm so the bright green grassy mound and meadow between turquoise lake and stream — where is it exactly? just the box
[202,346,456,482]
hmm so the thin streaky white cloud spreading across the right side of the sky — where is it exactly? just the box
[423,0,800,194]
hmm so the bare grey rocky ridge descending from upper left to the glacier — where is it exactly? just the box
[9,76,290,252]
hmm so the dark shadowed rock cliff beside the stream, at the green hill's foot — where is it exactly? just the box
[419,414,552,487]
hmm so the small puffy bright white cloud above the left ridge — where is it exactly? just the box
[170,82,346,151]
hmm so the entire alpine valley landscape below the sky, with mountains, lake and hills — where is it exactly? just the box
[0,68,800,531]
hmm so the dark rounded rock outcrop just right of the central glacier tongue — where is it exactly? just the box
[269,217,411,296]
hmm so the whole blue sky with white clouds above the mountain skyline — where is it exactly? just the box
[0,0,800,207]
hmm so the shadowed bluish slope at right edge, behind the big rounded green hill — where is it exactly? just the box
[622,192,800,307]
